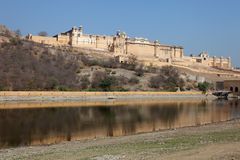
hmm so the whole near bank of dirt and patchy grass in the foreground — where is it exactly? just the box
[0,119,240,160]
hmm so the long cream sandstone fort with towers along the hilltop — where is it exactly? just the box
[26,26,232,69]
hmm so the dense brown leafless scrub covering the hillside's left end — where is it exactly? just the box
[0,42,79,90]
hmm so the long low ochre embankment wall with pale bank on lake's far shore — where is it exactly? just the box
[0,91,216,102]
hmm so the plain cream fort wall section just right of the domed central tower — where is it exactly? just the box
[127,43,155,59]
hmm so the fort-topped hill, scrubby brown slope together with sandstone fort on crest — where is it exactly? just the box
[0,25,240,93]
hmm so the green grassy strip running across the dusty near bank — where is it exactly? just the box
[23,128,240,159]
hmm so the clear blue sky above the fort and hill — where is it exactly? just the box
[0,0,240,66]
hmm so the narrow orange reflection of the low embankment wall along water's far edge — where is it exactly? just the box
[0,97,216,109]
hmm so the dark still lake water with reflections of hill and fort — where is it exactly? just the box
[0,100,240,148]
